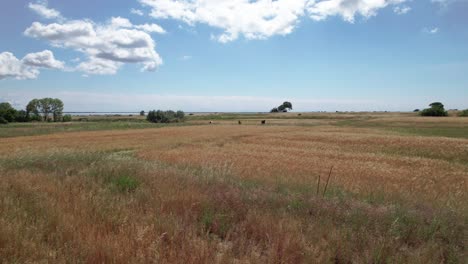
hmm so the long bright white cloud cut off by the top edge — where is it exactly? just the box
[139,0,406,43]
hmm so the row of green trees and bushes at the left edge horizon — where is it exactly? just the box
[0,98,71,124]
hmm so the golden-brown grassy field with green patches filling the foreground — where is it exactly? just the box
[0,113,468,263]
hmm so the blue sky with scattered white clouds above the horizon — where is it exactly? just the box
[0,0,468,112]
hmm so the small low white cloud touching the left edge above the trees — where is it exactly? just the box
[0,50,64,80]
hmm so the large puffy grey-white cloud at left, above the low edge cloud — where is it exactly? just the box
[24,17,164,75]
